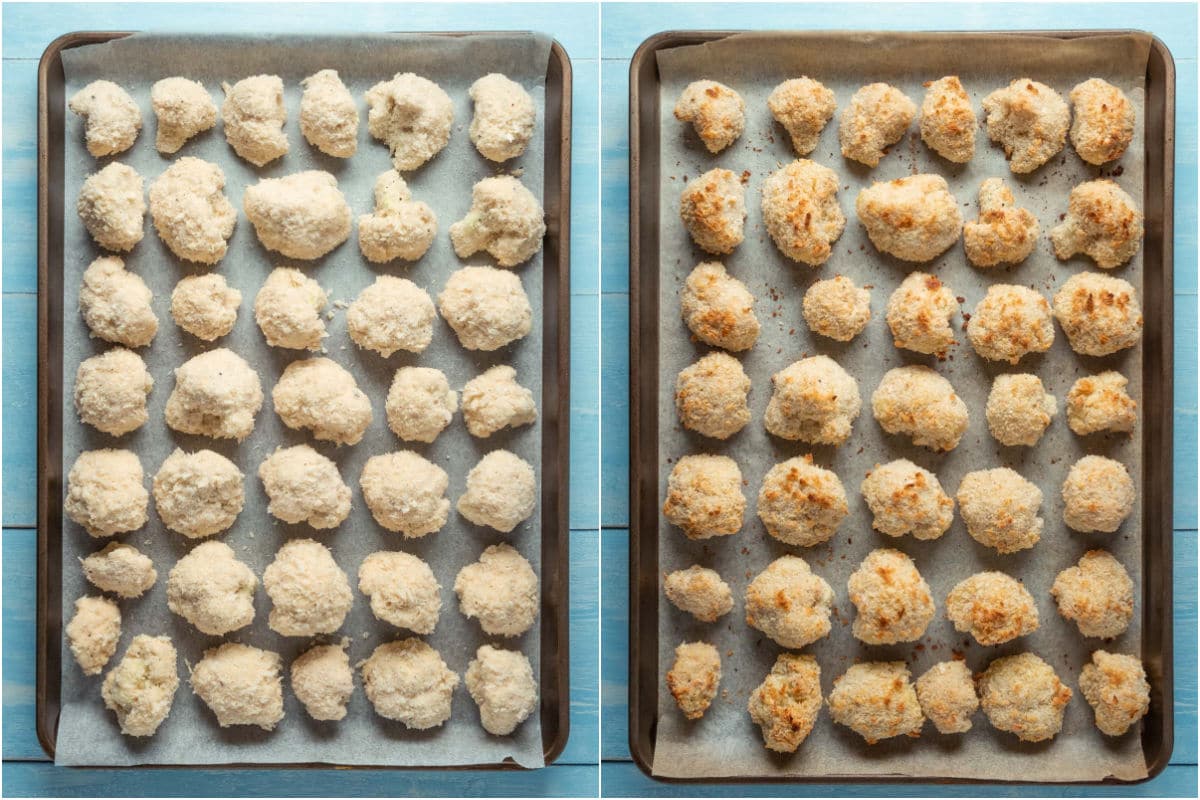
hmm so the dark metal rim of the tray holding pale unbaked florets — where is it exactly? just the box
[35,30,574,771]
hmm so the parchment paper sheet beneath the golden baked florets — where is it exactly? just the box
[654,34,1154,781]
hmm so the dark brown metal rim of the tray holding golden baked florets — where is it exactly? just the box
[628,29,1175,786]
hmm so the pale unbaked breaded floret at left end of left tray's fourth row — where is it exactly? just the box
[74,348,154,437]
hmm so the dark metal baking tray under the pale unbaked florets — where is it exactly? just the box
[35,31,571,770]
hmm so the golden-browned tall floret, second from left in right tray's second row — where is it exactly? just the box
[762,158,846,266]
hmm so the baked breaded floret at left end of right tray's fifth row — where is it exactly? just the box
[662,455,746,540]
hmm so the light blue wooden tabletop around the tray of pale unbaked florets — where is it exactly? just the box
[2,4,600,796]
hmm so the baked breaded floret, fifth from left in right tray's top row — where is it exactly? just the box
[983,78,1070,174]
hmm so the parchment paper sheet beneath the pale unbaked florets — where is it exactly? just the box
[56,31,551,766]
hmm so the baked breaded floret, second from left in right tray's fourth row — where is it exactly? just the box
[763,355,863,445]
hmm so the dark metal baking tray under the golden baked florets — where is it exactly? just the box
[629,30,1175,784]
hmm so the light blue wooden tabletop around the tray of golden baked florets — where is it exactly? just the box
[600,2,1196,798]
